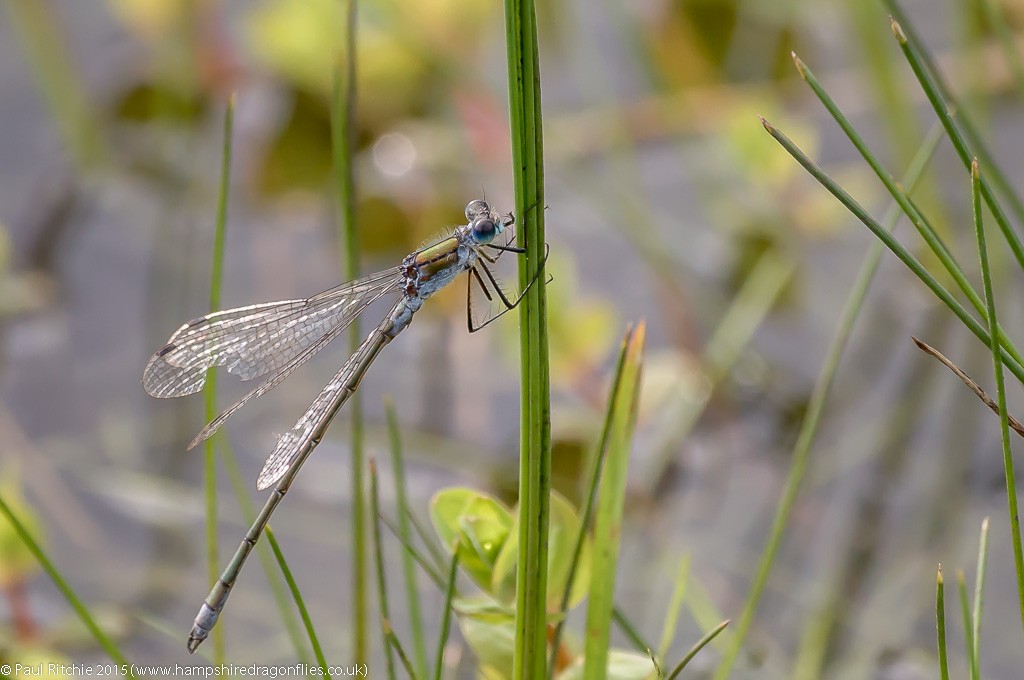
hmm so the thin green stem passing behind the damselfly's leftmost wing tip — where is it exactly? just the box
[203,93,234,664]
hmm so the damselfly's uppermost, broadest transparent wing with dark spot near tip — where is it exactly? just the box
[142,267,402,397]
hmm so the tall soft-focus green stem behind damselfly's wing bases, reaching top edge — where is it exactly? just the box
[331,0,370,663]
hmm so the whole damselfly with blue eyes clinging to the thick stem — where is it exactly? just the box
[142,201,547,651]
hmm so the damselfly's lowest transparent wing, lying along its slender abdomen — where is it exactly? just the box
[256,307,399,491]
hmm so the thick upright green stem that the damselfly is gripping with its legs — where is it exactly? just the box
[505,0,551,678]
